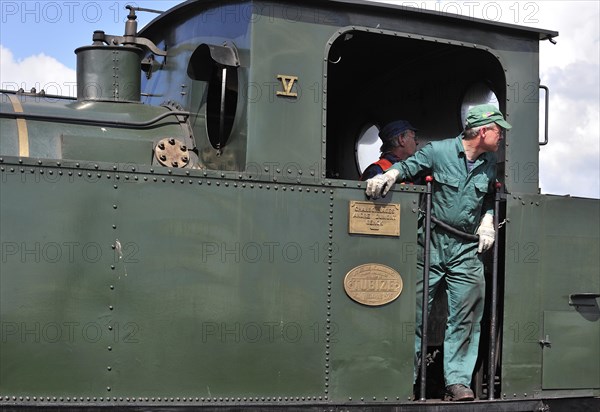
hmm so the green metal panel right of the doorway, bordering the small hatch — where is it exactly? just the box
[502,194,600,396]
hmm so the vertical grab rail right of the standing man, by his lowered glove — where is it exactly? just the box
[488,182,502,400]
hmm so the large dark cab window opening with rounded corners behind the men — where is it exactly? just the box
[322,26,506,180]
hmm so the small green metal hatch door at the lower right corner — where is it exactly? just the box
[542,312,600,389]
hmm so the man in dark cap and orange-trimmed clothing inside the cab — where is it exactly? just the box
[360,120,419,180]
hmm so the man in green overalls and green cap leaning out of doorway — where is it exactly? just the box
[366,104,511,401]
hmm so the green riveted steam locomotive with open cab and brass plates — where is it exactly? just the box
[0,0,600,411]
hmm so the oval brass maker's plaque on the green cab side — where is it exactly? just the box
[344,263,402,306]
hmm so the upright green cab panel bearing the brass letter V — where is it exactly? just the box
[247,4,332,176]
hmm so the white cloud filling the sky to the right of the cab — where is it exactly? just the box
[536,1,600,198]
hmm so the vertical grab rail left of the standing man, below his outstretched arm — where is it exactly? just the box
[419,176,433,401]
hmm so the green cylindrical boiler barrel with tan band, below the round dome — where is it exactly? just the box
[0,93,190,165]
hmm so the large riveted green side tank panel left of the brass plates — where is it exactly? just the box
[0,169,330,398]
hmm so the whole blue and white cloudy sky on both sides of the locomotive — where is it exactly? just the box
[0,0,600,198]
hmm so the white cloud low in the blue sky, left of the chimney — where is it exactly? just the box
[0,45,77,96]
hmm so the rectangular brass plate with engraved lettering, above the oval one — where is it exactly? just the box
[348,200,400,236]
